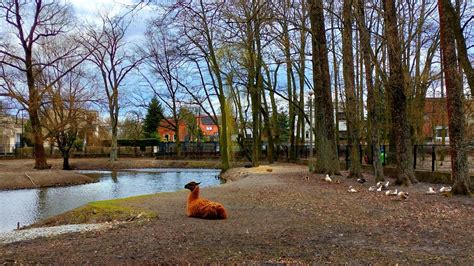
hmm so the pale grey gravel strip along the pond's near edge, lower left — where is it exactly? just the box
[0,223,112,244]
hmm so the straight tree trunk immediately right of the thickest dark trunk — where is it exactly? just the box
[342,0,362,178]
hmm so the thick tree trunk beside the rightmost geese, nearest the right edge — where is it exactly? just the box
[438,0,470,195]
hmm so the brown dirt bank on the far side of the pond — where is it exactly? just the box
[0,158,225,190]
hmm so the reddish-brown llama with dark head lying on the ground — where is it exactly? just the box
[184,181,227,219]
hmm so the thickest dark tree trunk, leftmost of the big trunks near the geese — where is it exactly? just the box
[308,0,340,174]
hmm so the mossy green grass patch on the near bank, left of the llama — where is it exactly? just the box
[30,195,157,227]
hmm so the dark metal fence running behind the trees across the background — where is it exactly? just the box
[0,142,474,171]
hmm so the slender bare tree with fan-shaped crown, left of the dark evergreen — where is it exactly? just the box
[87,12,144,161]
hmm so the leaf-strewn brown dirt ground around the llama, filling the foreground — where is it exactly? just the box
[0,164,474,264]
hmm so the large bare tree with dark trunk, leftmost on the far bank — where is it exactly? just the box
[0,0,88,169]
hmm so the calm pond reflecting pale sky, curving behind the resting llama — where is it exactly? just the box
[0,168,222,232]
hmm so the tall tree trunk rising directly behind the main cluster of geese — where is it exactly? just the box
[383,0,417,185]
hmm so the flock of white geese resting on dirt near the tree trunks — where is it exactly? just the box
[316,175,451,200]
